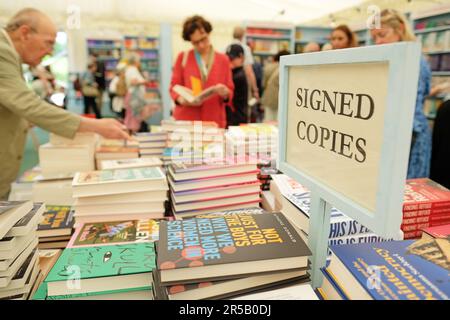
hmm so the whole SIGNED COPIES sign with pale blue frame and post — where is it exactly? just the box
[277,42,421,288]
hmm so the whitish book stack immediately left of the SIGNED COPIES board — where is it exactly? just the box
[225,124,278,161]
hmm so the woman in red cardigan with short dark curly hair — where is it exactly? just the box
[170,16,234,128]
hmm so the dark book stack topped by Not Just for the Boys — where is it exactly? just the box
[153,213,311,300]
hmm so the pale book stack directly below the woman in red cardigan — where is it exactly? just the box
[161,120,225,164]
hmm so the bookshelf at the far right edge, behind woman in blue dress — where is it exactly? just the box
[411,8,450,125]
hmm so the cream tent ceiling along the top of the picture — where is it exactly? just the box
[0,0,364,24]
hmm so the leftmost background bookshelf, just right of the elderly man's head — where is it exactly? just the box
[86,39,122,87]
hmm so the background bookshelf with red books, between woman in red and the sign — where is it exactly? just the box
[245,23,295,64]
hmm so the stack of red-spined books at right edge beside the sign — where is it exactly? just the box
[402,178,450,239]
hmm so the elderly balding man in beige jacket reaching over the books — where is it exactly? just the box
[0,9,129,200]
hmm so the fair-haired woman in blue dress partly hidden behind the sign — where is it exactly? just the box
[370,9,431,179]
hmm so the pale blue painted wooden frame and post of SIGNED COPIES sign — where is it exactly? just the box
[277,42,421,287]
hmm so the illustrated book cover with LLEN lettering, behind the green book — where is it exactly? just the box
[67,219,159,248]
